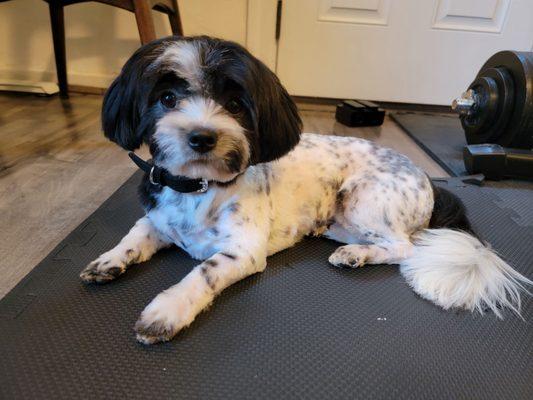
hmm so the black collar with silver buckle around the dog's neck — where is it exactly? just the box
[128,152,209,193]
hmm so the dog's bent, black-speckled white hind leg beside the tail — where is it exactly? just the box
[325,173,432,268]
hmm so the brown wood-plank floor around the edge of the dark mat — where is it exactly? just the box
[0,93,446,298]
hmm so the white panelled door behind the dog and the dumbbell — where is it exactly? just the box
[276,0,533,104]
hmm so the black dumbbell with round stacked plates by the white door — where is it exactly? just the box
[452,51,533,179]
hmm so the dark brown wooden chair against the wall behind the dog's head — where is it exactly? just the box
[44,0,183,98]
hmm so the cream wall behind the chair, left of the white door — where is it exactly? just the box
[0,0,247,87]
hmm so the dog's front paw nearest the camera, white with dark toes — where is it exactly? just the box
[134,292,194,344]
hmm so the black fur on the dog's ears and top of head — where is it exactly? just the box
[102,36,302,165]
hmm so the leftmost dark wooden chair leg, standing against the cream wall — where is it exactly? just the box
[49,1,68,98]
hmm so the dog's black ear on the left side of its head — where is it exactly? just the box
[102,38,172,151]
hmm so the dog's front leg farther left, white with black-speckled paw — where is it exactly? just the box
[80,217,170,283]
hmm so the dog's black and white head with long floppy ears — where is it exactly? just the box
[102,37,301,182]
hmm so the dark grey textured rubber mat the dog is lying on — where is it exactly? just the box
[0,174,533,399]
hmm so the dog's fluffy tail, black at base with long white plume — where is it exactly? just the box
[400,187,533,318]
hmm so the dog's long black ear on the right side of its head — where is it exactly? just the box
[250,60,302,162]
